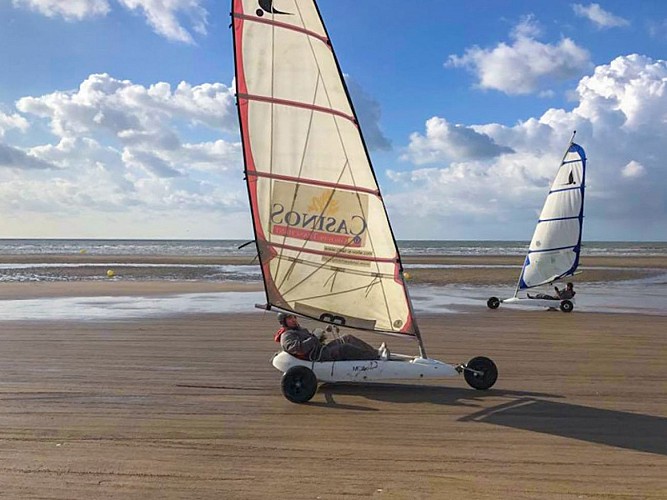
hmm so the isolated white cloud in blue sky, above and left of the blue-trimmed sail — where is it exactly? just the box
[446,17,590,94]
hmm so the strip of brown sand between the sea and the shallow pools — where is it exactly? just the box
[0,254,667,292]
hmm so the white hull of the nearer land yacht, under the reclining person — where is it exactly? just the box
[272,352,459,382]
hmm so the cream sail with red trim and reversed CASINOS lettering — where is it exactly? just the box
[232,0,418,336]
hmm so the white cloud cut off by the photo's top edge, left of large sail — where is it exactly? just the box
[12,0,208,44]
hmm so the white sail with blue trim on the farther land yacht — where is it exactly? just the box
[517,141,586,291]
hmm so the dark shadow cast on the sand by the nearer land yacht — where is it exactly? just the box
[310,384,667,455]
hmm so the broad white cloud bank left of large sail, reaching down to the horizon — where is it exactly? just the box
[0,74,250,237]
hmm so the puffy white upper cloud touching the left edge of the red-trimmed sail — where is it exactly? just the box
[17,74,237,145]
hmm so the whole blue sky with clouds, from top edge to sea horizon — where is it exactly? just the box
[0,0,667,243]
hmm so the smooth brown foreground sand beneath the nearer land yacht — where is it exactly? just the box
[0,308,667,499]
